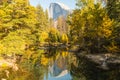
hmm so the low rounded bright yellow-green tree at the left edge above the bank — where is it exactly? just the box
[0,32,26,54]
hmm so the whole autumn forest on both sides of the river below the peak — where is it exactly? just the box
[0,0,120,80]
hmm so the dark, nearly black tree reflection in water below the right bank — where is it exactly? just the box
[70,56,120,80]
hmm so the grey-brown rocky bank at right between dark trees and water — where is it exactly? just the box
[76,52,120,70]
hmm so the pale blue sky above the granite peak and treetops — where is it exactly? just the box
[30,0,76,10]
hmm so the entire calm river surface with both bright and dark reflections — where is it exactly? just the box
[0,48,120,80]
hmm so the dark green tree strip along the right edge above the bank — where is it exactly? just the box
[106,0,120,53]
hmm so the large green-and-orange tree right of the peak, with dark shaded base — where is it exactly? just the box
[69,0,114,53]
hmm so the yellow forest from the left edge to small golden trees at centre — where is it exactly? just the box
[0,0,68,54]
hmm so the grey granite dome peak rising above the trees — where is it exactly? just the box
[49,3,70,21]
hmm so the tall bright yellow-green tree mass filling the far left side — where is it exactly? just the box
[0,0,37,54]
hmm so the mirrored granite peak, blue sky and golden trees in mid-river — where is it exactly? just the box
[41,49,72,80]
